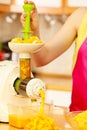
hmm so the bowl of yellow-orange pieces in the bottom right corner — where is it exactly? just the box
[65,110,87,130]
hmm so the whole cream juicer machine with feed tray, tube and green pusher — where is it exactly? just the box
[0,4,45,122]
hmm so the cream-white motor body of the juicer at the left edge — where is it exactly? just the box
[0,61,29,122]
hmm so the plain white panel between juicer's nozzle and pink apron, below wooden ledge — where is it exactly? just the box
[46,90,71,107]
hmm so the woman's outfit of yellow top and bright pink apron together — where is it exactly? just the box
[70,11,87,111]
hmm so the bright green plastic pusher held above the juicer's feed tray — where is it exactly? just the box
[23,4,34,40]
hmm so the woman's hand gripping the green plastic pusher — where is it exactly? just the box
[20,0,39,37]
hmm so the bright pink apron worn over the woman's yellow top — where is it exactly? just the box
[70,38,87,111]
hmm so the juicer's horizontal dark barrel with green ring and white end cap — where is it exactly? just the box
[13,78,45,100]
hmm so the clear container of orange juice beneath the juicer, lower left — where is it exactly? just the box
[8,104,43,129]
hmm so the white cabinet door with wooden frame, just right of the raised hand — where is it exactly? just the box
[34,0,64,14]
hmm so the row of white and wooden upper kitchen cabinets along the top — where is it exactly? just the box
[0,0,87,15]
